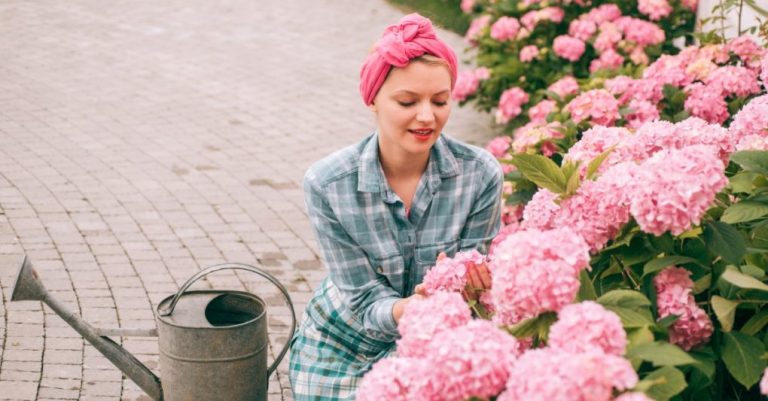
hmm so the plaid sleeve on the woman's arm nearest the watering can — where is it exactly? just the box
[304,177,401,342]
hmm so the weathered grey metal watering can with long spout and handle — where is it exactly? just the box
[11,256,296,401]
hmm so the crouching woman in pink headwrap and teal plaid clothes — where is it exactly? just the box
[290,14,503,401]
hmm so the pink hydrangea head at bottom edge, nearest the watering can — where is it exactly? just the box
[356,358,444,401]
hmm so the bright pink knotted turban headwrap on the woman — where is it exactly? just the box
[360,13,457,105]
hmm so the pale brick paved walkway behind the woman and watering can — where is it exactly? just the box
[0,0,496,401]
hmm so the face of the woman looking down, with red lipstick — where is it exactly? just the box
[369,61,451,155]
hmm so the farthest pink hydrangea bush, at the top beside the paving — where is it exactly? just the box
[454,0,697,129]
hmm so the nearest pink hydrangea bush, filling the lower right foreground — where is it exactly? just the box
[358,94,768,401]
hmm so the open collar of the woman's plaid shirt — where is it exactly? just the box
[357,132,459,192]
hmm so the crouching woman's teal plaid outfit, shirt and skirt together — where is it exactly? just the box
[291,133,503,400]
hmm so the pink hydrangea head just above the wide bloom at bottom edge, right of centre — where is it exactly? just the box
[548,301,627,356]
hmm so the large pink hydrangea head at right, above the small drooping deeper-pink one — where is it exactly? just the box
[628,145,728,235]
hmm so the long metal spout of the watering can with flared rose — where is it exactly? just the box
[11,255,163,401]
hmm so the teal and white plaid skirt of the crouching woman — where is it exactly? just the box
[289,278,395,401]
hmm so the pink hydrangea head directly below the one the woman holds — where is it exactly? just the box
[397,292,472,357]
